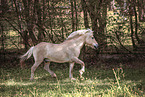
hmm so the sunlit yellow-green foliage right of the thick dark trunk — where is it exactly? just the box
[106,7,144,53]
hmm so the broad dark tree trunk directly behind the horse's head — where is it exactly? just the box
[88,0,107,46]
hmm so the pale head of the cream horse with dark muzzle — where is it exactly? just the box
[85,29,98,49]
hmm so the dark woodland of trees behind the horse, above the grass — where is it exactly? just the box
[0,0,145,66]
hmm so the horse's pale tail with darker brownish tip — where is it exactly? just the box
[20,46,34,68]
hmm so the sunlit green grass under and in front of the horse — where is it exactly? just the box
[0,65,145,97]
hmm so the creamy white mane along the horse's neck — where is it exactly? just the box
[67,29,93,40]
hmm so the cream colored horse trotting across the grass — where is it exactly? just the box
[21,29,98,80]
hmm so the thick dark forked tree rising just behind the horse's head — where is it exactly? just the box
[81,0,111,51]
